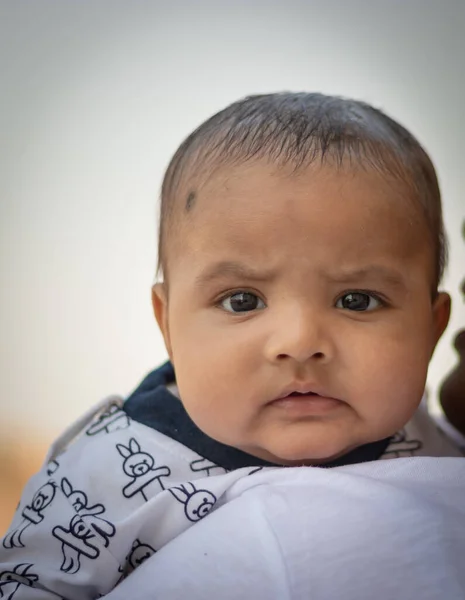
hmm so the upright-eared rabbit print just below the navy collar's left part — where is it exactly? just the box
[116,438,171,500]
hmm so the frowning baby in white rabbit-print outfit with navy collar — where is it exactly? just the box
[0,93,460,600]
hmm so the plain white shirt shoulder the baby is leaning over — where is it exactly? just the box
[107,458,465,600]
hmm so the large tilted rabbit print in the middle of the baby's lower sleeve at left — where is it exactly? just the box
[52,477,116,574]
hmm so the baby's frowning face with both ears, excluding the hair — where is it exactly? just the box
[154,163,448,464]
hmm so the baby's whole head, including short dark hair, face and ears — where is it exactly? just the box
[153,93,449,464]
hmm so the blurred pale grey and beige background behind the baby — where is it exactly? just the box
[0,0,465,531]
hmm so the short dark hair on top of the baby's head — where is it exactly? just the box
[158,92,447,289]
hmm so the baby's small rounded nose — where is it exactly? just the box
[266,306,334,363]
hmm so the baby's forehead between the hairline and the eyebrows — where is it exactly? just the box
[166,162,434,282]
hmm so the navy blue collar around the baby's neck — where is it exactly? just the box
[124,362,390,471]
